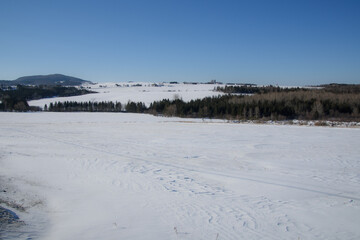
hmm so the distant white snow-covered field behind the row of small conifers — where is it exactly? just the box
[29,82,222,108]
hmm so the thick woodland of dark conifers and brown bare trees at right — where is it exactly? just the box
[148,89,360,121]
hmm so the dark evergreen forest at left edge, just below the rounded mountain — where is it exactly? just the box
[0,85,93,111]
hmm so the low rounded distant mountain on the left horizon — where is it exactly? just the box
[0,74,91,86]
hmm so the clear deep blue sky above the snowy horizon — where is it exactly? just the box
[0,0,360,85]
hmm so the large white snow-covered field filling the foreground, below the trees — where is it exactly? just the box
[0,112,360,240]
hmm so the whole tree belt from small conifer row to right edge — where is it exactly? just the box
[45,84,360,121]
